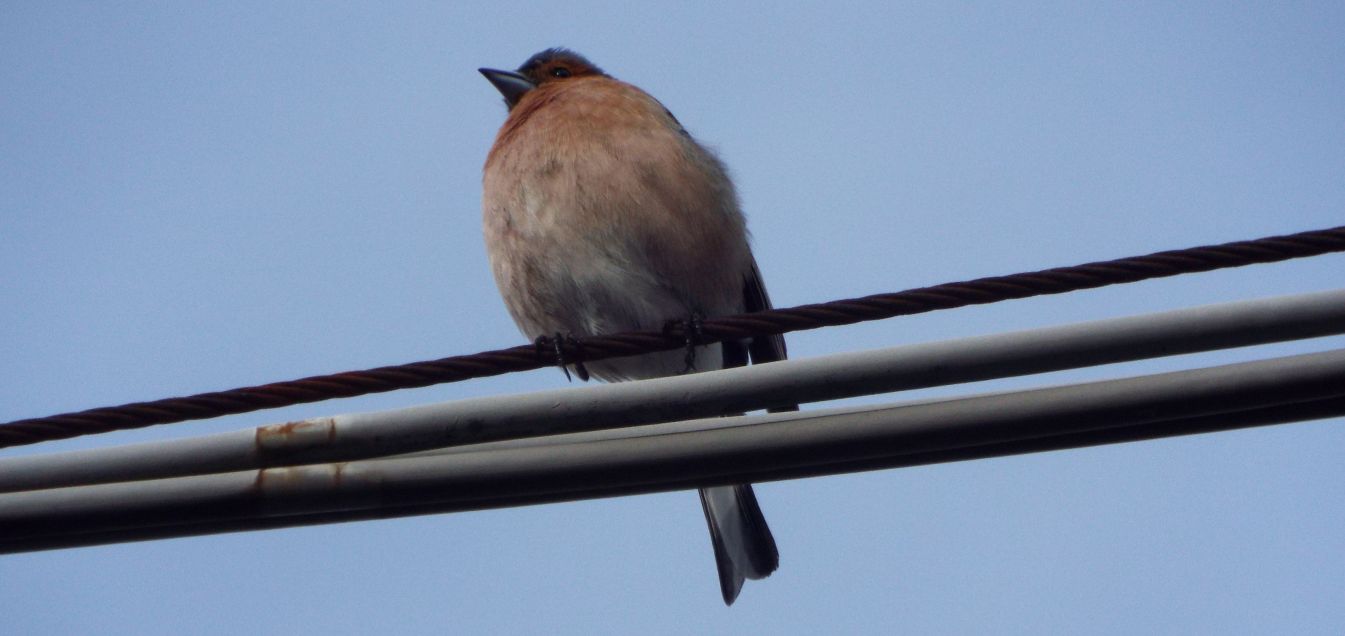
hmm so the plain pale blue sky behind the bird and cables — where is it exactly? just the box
[0,1,1345,635]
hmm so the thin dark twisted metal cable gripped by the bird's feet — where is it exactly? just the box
[0,226,1345,448]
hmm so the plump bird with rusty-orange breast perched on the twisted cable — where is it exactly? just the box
[480,48,788,604]
